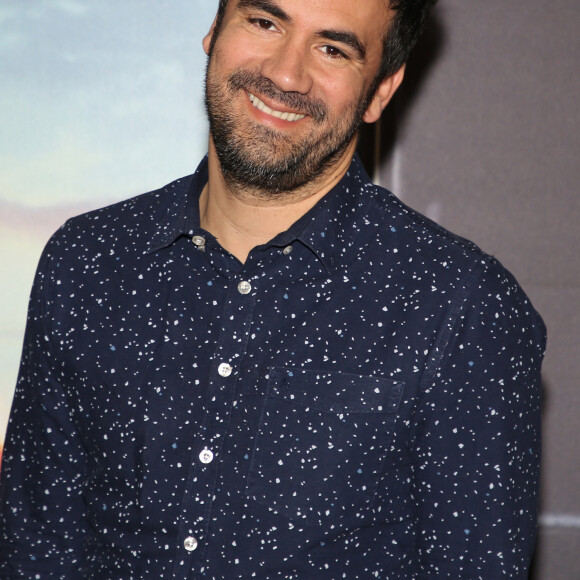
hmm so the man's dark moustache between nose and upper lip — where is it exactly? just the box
[228,71,328,123]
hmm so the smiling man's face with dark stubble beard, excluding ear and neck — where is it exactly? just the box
[204,0,389,195]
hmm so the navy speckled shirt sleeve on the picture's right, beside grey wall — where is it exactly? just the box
[414,261,545,580]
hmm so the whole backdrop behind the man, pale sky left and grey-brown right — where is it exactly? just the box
[0,0,580,580]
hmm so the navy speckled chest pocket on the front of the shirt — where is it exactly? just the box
[246,368,404,525]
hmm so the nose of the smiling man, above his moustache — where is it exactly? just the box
[261,39,312,95]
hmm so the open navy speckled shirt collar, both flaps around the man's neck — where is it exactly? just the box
[147,154,372,272]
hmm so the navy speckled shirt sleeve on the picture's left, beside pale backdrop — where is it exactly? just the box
[0,233,86,579]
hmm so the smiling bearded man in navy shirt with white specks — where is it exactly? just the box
[2,0,544,580]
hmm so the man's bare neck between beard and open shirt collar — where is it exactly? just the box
[199,138,356,263]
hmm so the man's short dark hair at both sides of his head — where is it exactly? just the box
[214,0,437,79]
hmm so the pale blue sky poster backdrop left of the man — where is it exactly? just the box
[0,0,217,441]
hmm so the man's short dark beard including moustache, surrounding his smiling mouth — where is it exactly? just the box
[205,62,369,198]
